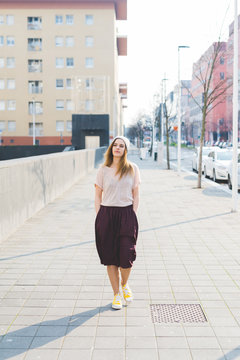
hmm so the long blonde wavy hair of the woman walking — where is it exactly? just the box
[103,139,134,179]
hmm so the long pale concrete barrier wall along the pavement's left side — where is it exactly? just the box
[0,149,101,241]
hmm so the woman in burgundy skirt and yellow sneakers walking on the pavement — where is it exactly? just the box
[95,136,140,309]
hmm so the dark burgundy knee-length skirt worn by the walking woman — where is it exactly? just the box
[95,205,138,268]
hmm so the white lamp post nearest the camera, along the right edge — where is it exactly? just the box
[232,0,238,212]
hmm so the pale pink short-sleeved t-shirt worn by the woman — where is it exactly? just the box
[95,163,141,206]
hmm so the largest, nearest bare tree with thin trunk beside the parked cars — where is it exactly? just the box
[182,41,232,188]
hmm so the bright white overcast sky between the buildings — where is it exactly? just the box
[119,0,234,124]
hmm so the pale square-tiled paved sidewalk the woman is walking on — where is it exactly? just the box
[0,156,240,360]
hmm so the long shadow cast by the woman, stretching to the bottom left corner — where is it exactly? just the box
[0,304,111,360]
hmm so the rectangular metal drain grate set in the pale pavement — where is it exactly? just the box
[150,304,207,323]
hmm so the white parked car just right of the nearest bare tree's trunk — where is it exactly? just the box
[203,147,233,181]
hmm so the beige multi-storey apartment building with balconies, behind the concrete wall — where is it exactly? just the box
[0,0,127,145]
